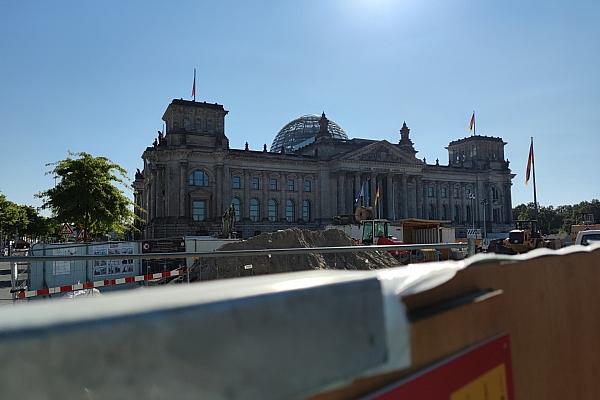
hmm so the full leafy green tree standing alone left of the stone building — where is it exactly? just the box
[37,153,135,238]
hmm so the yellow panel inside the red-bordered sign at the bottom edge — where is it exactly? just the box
[450,364,508,400]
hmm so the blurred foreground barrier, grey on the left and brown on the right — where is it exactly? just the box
[0,245,600,399]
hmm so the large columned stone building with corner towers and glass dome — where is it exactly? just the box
[133,100,514,239]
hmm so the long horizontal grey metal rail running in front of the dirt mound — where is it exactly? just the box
[0,243,467,263]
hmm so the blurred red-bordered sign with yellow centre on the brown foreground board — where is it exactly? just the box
[368,335,514,400]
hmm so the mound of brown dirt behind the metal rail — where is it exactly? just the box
[190,228,400,281]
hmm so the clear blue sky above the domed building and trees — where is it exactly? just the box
[0,0,600,205]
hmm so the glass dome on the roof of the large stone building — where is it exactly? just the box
[271,115,348,153]
